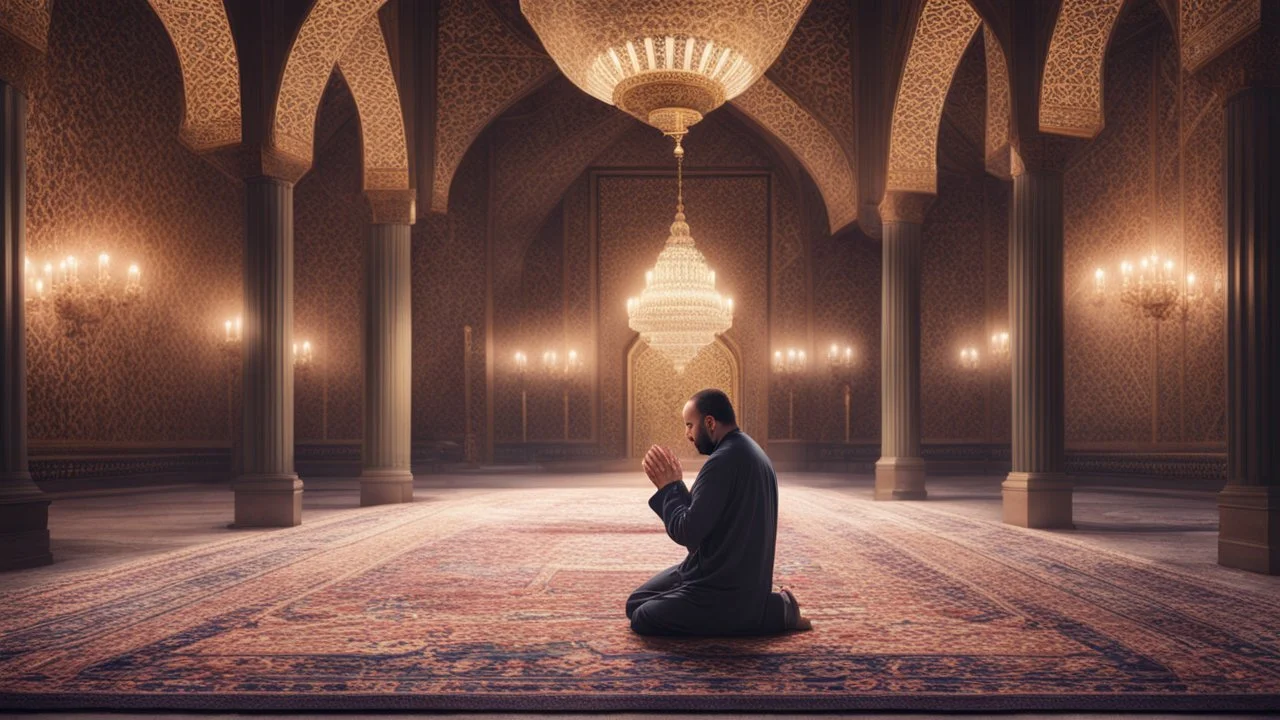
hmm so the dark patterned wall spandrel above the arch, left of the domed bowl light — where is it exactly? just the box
[431,0,556,213]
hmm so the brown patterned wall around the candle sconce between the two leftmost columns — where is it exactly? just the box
[27,0,243,445]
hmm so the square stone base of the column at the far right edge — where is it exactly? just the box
[1217,484,1280,575]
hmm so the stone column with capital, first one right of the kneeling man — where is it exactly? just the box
[876,191,933,500]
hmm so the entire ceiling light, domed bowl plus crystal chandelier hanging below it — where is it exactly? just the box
[520,0,809,373]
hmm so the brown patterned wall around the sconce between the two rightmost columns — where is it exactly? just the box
[1064,3,1225,446]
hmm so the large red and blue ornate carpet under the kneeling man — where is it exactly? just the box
[0,486,1280,711]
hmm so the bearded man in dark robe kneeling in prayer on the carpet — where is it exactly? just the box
[627,389,813,635]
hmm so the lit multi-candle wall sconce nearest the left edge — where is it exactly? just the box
[23,252,142,337]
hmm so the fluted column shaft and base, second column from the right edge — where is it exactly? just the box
[1004,167,1071,528]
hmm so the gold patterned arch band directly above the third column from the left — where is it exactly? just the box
[338,13,408,190]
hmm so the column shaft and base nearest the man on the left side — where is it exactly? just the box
[360,223,413,505]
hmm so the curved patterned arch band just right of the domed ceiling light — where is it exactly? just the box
[732,77,858,233]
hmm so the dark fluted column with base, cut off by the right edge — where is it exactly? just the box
[1217,87,1280,575]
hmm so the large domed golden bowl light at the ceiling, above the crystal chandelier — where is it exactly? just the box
[520,0,809,135]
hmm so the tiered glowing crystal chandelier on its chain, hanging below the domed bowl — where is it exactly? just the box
[627,136,733,373]
